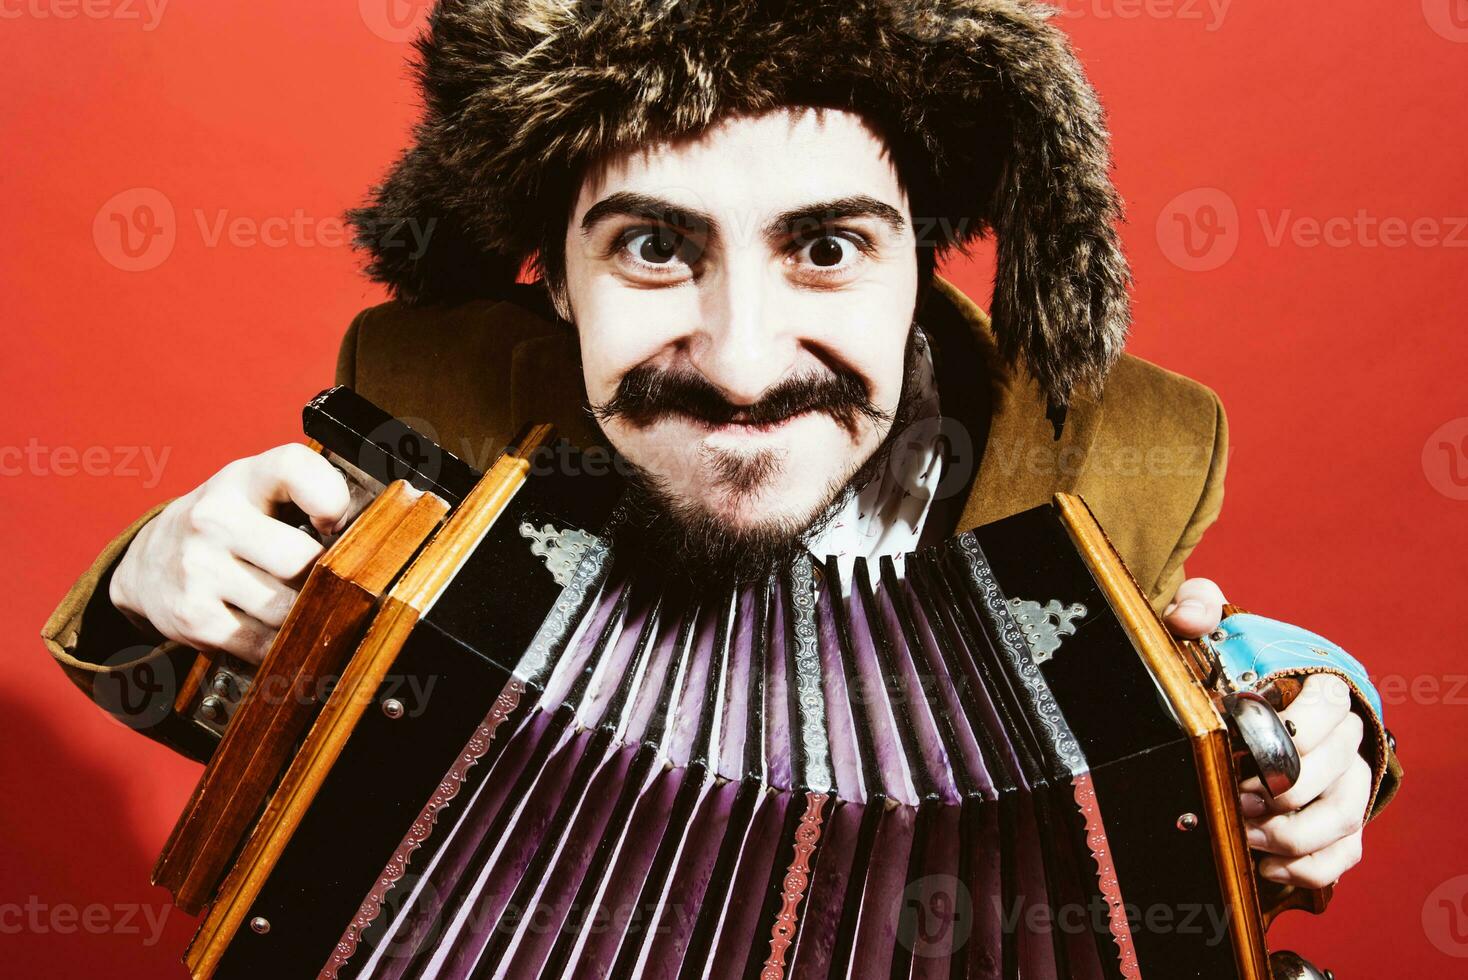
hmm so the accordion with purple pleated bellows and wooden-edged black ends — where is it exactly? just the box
[154,389,1326,980]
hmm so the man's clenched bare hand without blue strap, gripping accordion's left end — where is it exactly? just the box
[109,445,351,663]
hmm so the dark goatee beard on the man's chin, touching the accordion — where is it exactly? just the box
[617,326,925,590]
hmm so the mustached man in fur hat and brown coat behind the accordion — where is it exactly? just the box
[46,0,1399,921]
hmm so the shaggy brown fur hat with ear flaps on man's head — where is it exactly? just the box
[351,0,1129,406]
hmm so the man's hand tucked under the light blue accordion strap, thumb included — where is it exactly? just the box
[1163,578,1371,888]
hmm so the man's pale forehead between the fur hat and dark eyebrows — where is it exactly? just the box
[574,107,907,220]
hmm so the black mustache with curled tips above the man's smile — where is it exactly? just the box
[592,364,893,430]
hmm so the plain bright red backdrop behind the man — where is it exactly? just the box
[0,0,1468,977]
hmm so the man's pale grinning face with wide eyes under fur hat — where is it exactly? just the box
[565,109,918,551]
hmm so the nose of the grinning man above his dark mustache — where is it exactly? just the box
[688,263,800,405]
